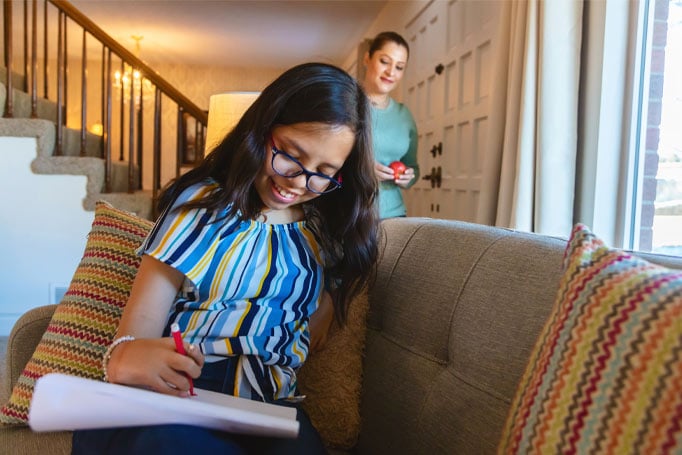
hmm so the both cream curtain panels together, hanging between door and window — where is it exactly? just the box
[477,0,640,241]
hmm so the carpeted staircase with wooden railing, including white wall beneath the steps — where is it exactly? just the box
[0,0,208,334]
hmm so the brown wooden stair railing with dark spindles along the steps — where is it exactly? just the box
[3,0,208,199]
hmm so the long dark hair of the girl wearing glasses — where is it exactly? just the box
[159,63,378,322]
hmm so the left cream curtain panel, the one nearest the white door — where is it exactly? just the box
[477,0,582,239]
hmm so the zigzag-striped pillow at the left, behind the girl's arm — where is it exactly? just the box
[0,201,153,425]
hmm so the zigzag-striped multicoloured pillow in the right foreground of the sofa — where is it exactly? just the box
[498,225,682,454]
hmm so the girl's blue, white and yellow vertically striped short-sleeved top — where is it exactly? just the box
[140,184,323,400]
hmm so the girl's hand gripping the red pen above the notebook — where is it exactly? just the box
[107,337,204,396]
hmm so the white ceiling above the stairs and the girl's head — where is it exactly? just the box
[71,0,387,68]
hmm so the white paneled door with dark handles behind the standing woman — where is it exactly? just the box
[403,0,500,221]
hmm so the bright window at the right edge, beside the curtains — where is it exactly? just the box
[631,0,682,256]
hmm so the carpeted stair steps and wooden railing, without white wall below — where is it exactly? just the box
[0,0,208,219]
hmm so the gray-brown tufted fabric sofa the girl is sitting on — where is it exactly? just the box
[0,218,682,455]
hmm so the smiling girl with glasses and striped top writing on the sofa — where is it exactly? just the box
[73,63,378,454]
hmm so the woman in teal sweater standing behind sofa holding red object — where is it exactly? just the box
[363,32,419,219]
